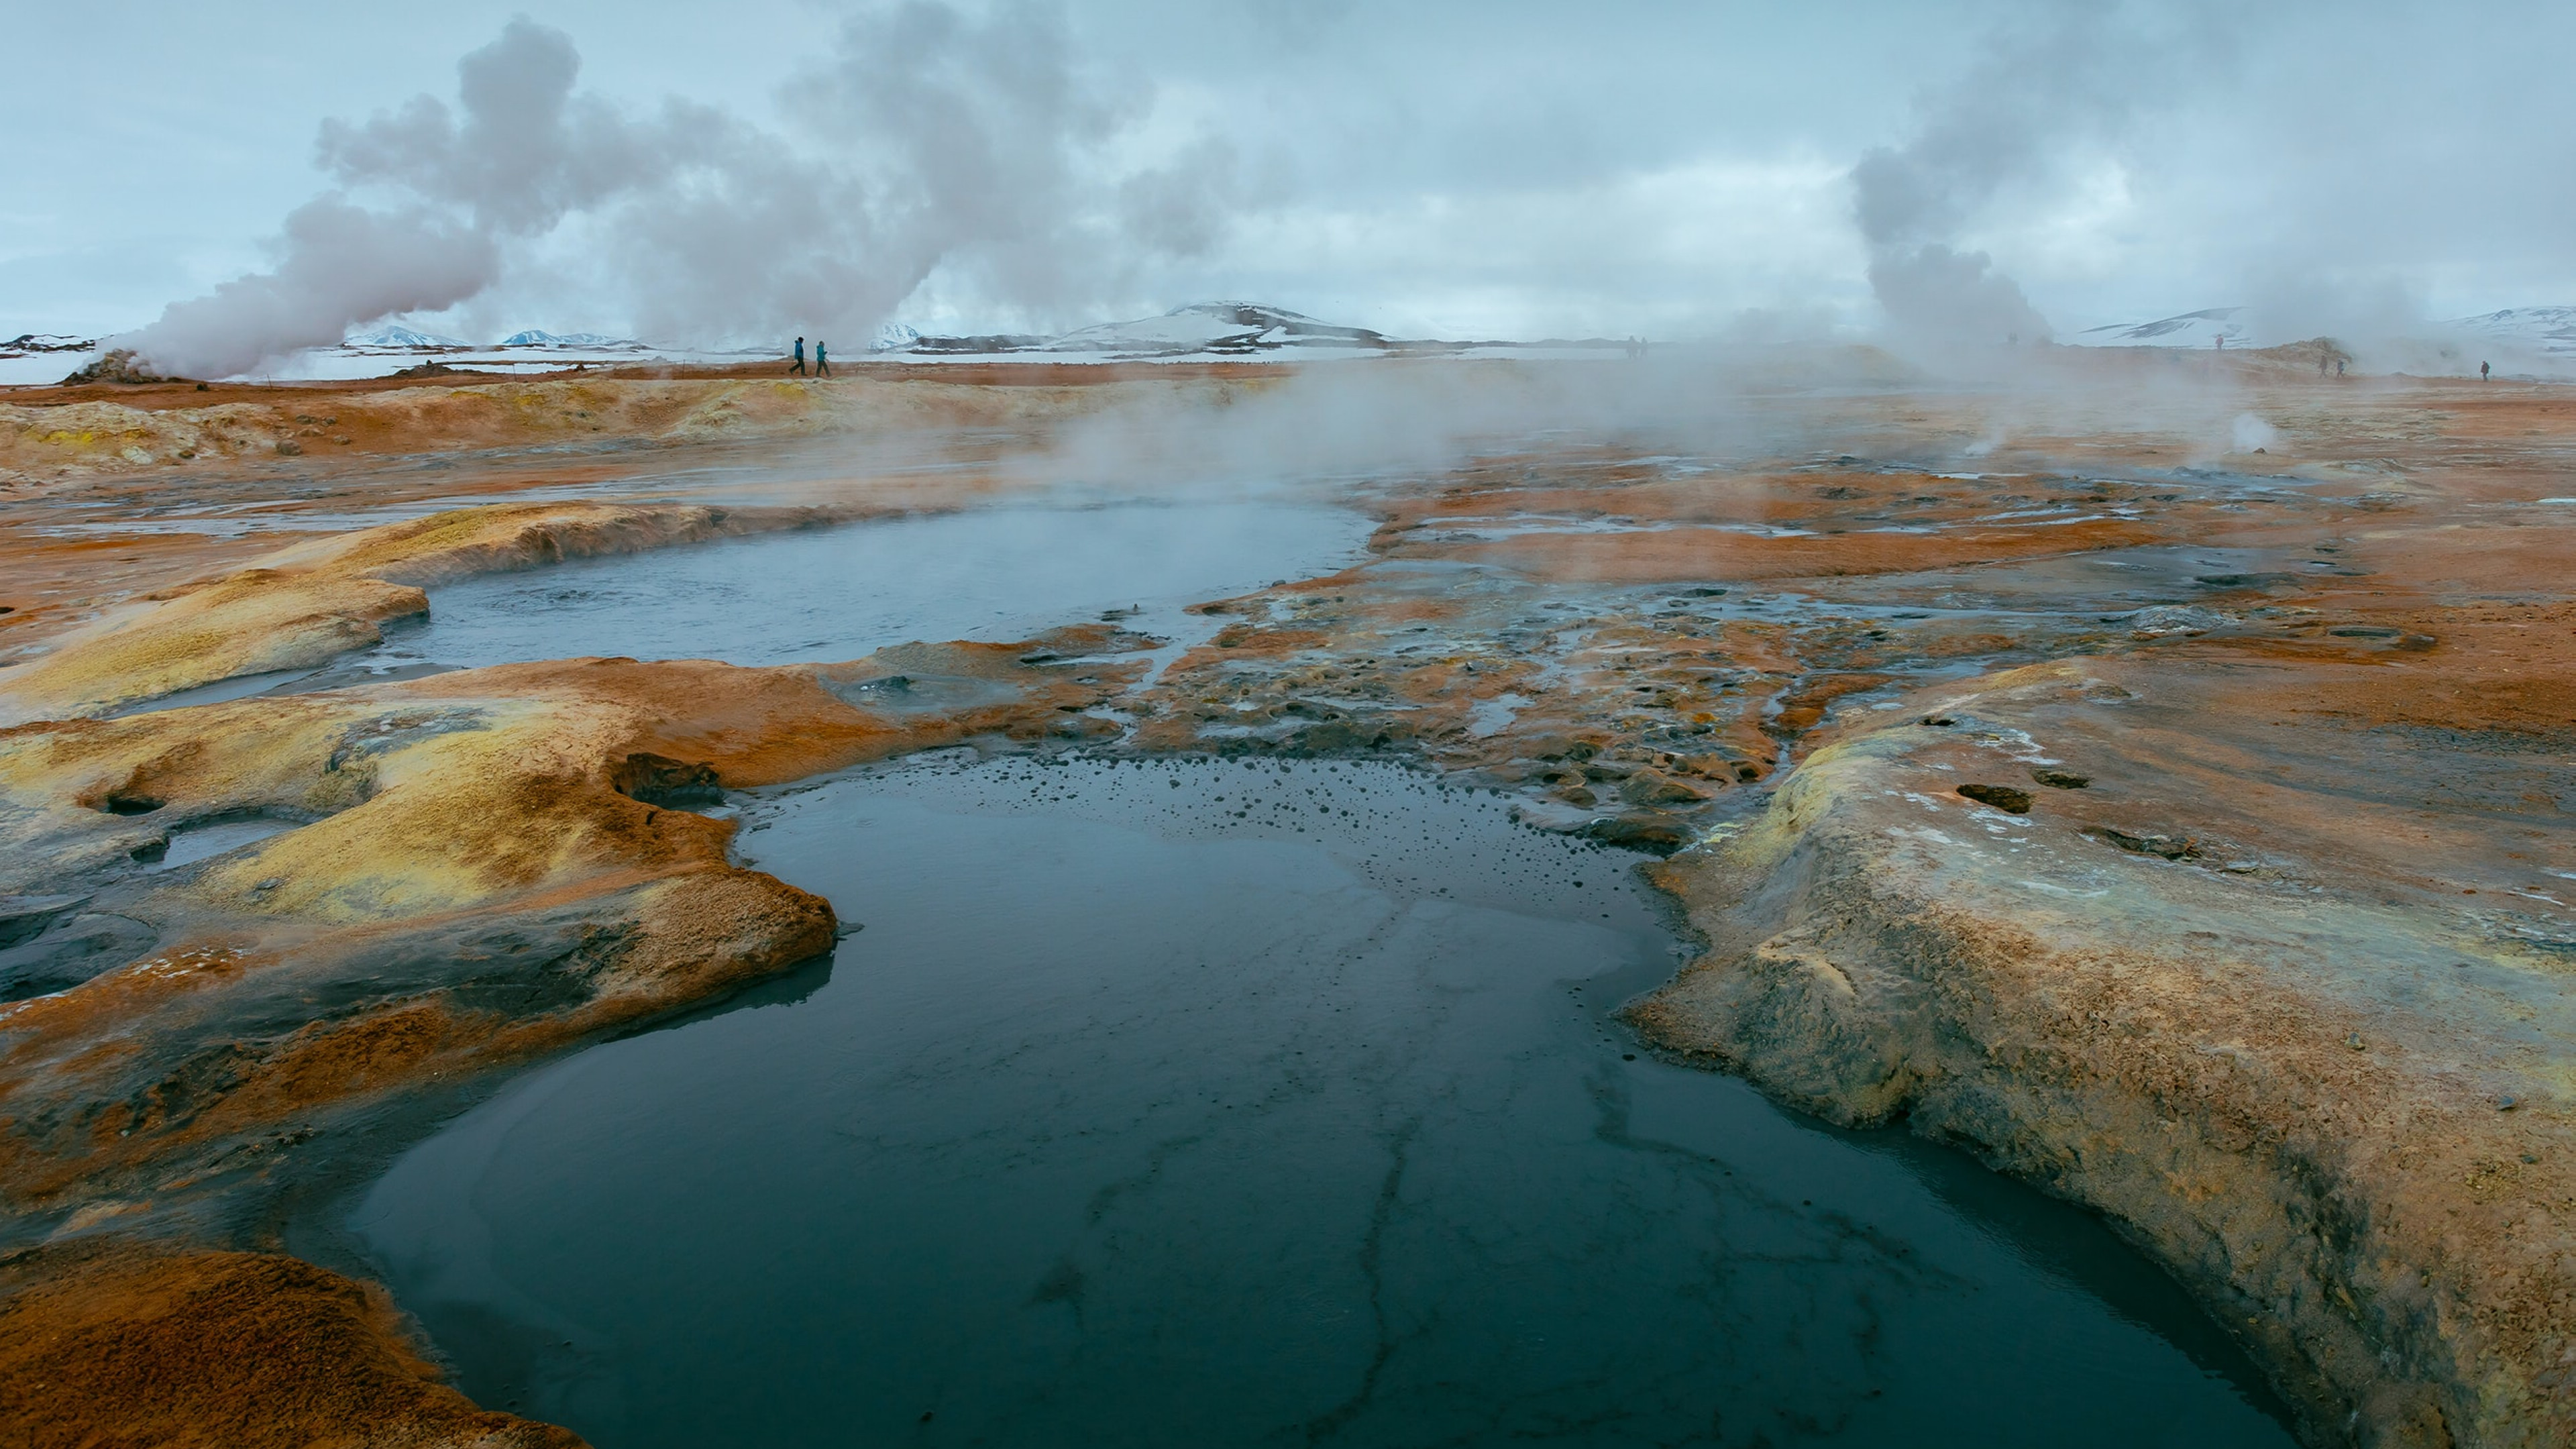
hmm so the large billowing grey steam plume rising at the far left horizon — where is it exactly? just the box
[116,0,1236,376]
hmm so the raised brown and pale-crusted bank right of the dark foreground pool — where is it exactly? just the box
[1633,657,2576,1446]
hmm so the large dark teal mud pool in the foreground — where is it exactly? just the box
[337,753,2293,1449]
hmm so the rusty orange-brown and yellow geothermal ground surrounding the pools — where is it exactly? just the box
[0,351,2576,1446]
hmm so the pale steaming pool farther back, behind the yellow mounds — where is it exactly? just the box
[366,500,1371,670]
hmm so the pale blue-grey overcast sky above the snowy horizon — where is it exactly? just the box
[0,0,2576,340]
